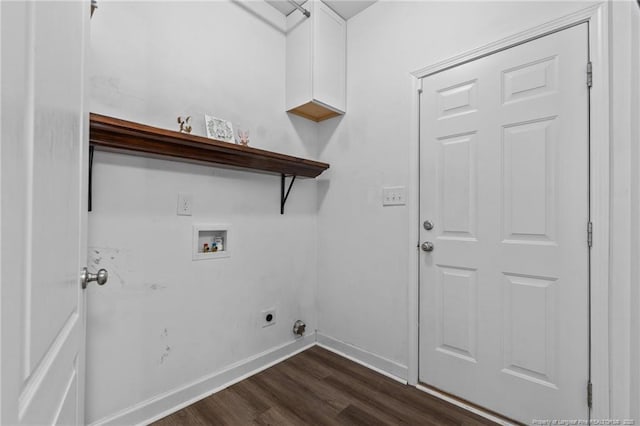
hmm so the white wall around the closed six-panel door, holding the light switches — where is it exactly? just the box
[318,1,640,416]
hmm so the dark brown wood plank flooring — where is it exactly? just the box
[154,346,494,426]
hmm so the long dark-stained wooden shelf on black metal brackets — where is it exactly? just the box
[89,113,329,178]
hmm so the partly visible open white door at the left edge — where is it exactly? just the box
[0,1,89,425]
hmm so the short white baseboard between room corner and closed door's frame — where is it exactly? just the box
[316,332,409,385]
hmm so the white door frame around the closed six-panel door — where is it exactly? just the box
[408,2,610,419]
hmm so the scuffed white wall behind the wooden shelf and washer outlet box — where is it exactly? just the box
[86,1,317,423]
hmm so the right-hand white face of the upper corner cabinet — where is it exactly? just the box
[311,2,347,112]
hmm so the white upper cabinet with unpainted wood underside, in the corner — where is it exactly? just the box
[286,0,347,121]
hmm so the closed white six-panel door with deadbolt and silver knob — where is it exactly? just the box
[419,24,589,423]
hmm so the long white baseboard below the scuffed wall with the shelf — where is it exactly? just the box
[90,333,316,426]
